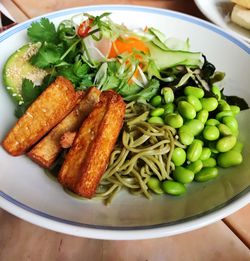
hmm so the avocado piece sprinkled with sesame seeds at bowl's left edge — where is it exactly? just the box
[3,43,48,104]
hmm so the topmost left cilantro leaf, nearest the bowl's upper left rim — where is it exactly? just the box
[27,17,57,43]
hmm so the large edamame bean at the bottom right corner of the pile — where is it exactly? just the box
[217,149,243,168]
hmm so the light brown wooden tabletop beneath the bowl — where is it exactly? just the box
[0,0,250,261]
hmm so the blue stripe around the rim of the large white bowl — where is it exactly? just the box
[0,5,250,236]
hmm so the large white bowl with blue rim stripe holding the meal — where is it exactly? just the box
[0,5,250,239]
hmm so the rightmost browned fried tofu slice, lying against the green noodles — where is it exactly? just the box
[58,91,126,198]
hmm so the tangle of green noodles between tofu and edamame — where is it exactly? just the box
[96,102,185,202]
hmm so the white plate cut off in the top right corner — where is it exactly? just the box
[195,0,250,42]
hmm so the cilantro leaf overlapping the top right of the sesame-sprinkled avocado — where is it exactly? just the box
[30,42,63,69]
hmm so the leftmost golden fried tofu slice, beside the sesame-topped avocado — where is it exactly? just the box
[2,77,78,156]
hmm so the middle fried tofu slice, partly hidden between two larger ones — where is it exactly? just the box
[28,87,101,168]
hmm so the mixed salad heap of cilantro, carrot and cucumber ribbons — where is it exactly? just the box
[2,13,248,117]
